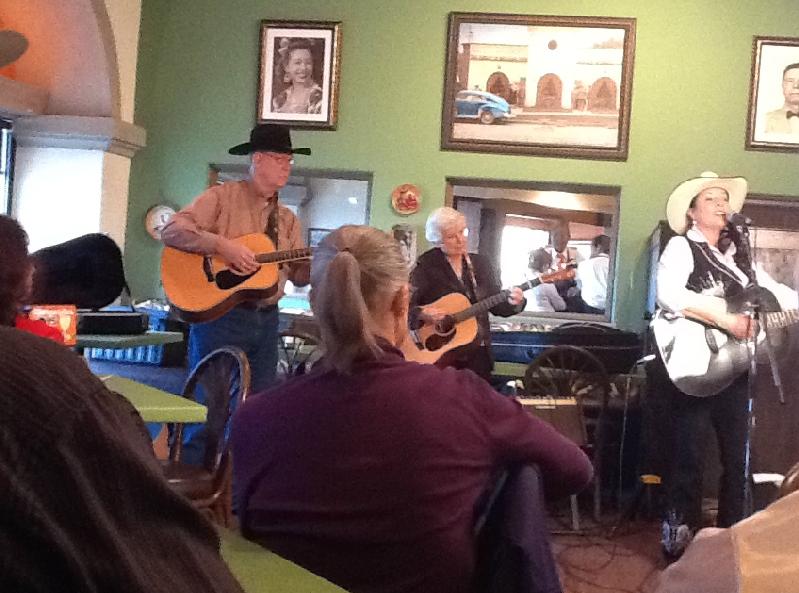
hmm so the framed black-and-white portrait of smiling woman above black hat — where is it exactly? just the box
[257,21,341,130]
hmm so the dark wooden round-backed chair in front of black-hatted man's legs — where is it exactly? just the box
[162,347,250,527]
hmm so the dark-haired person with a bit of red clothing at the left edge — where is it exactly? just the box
[0,215,64,344]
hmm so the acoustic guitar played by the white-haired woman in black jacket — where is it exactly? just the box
[402,264,577,364]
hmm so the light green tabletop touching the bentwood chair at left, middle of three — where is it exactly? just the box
[100,375,208,422]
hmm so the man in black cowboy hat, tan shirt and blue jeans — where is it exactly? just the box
[161,124,311,462]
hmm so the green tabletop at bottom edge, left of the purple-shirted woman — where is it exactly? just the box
[219,527,346,593]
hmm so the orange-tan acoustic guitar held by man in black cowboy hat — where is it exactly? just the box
[161,233,311,323]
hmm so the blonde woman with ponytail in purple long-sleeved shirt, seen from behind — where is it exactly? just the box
[231,226,592,593]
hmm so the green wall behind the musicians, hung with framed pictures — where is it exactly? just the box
[126,0,799,329]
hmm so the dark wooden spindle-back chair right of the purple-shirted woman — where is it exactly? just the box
[521,346,610,531]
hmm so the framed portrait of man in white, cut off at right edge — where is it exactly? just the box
[746,37,799,152]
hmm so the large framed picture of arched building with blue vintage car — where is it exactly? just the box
[441,13,636,160]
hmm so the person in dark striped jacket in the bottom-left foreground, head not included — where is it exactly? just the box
[0,327,241,593]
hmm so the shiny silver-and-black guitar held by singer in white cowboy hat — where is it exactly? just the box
[652,287,799,397]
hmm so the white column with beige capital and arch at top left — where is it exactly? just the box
[6,0,145,249]
